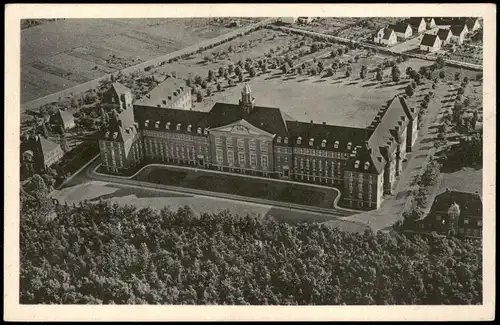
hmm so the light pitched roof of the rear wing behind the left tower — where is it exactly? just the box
[136,76,191,107]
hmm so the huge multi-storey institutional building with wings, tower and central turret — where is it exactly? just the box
[99,77,418,209]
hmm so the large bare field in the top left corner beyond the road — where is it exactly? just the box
[21,18,260,103]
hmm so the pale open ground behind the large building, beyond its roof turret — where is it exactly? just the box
[191,58,426,127]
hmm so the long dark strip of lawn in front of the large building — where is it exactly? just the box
[134,167,337,208]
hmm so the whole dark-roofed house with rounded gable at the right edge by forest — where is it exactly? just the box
[416,189,483,238]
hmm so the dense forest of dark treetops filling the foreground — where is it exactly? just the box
[20,177,482,305]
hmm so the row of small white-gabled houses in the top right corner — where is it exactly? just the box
[373,17,481,47]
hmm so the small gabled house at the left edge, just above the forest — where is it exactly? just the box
[21,135,64,172]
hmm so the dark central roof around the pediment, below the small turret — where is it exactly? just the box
[200,103,288,137]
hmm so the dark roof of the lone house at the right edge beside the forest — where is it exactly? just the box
[430,190,483,216]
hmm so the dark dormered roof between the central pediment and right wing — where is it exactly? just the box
[286,121,373,153]
